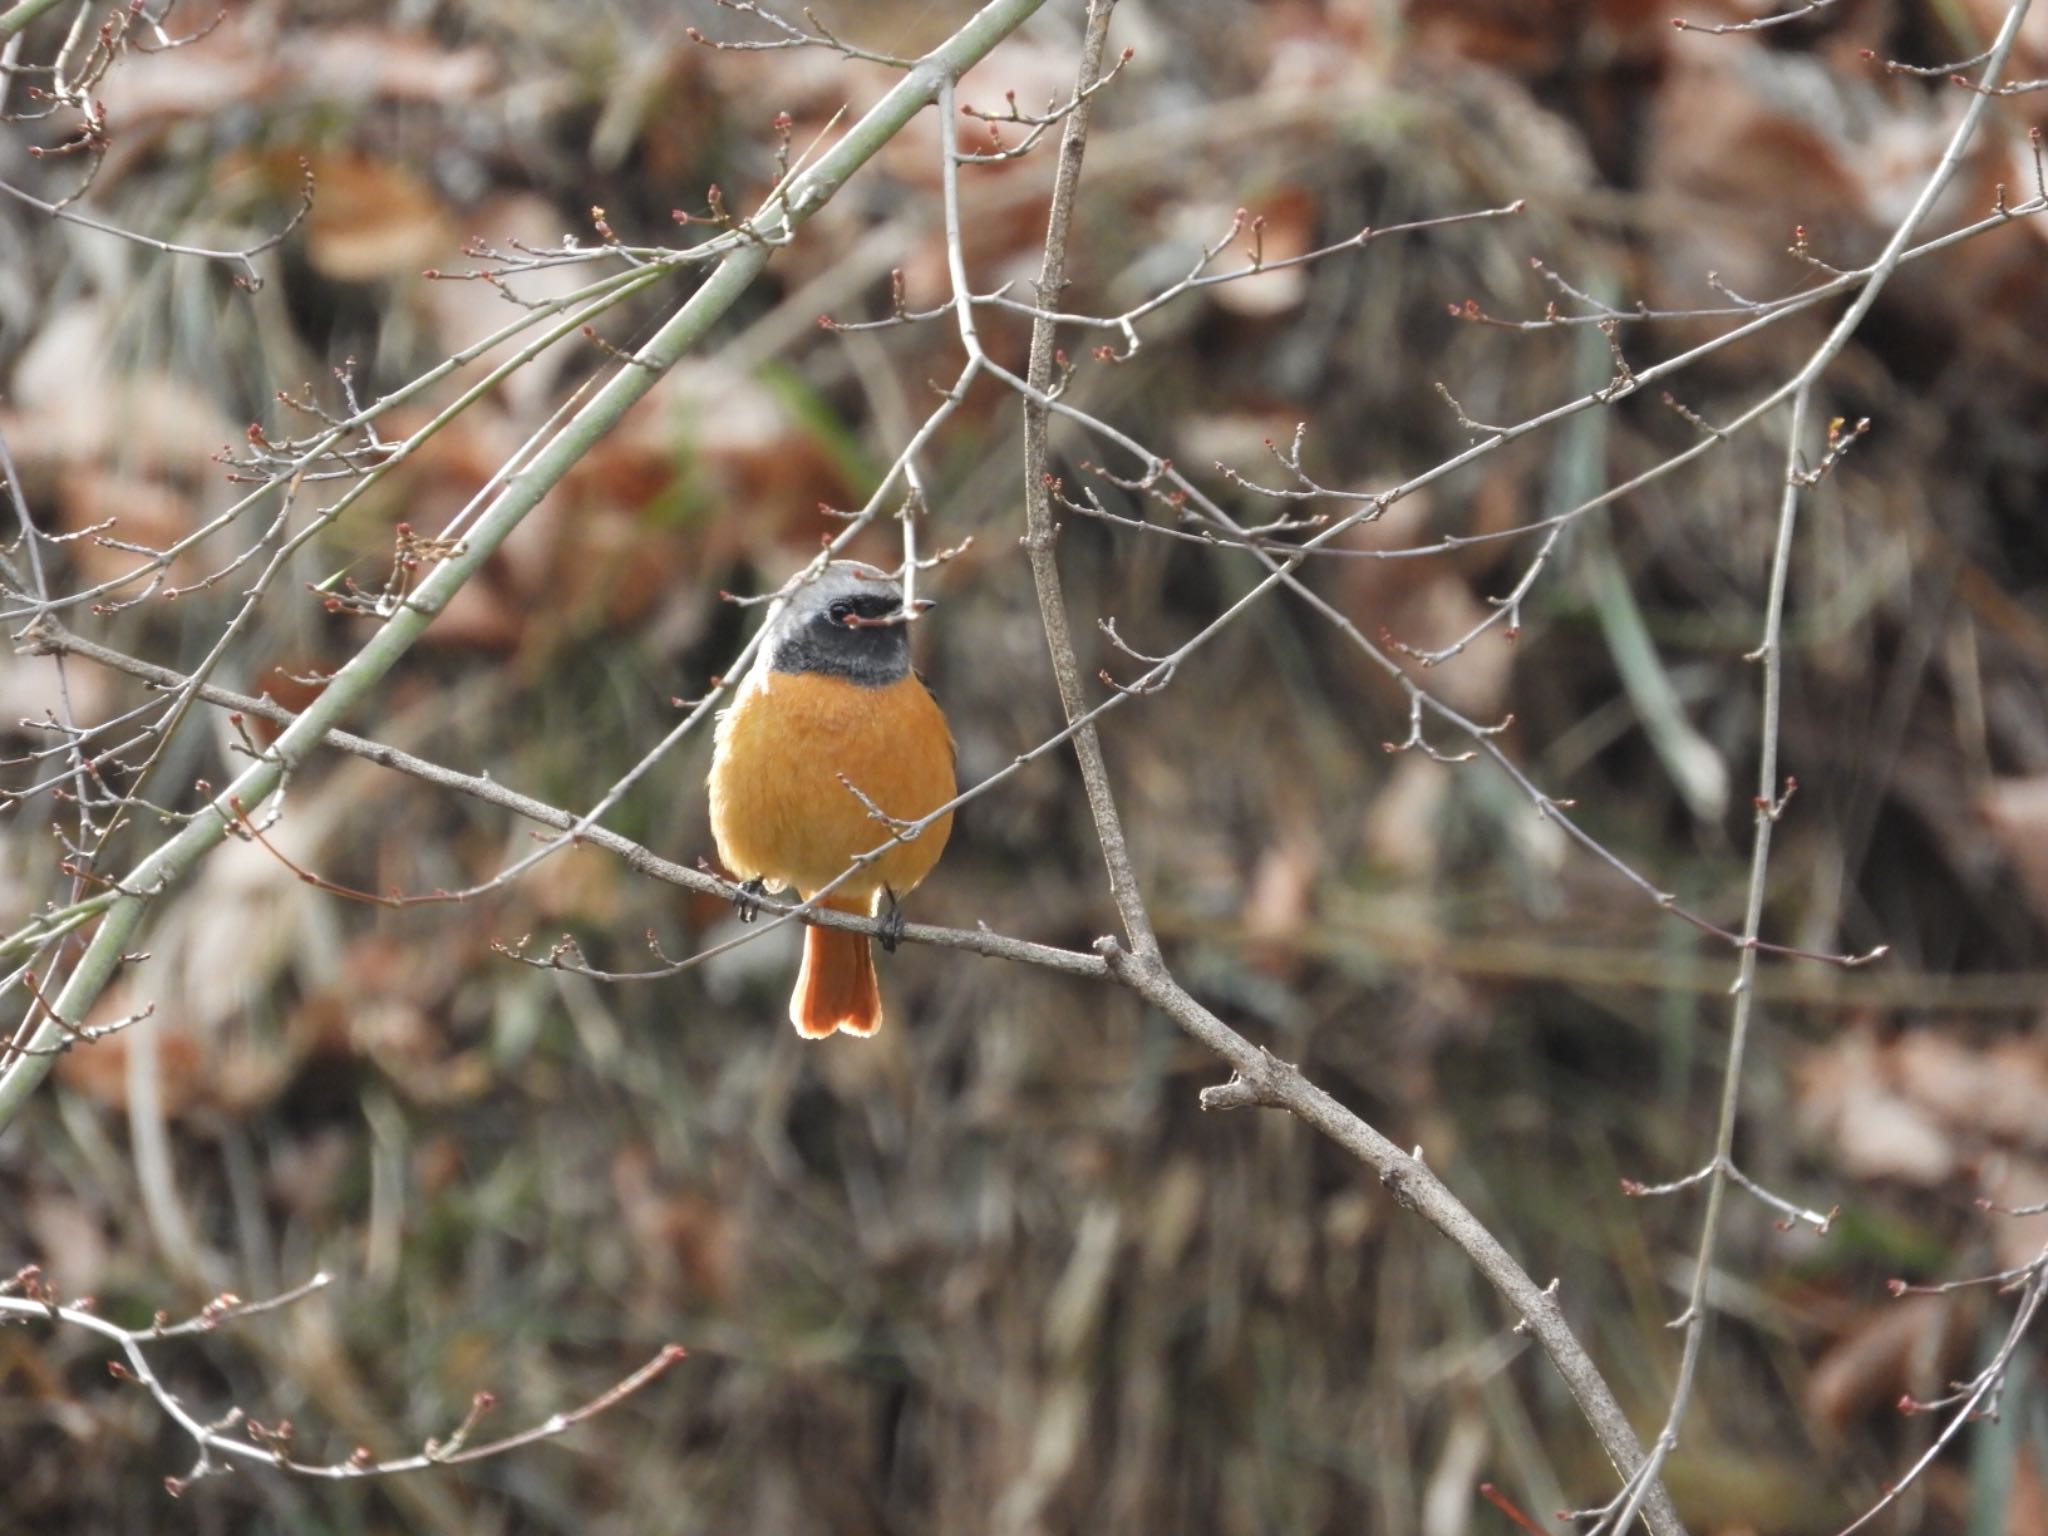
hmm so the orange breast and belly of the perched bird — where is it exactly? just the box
[711,668,954,911]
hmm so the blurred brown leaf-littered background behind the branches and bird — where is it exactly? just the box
[0,0,2048,1536]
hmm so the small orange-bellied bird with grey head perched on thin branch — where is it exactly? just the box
[709,559,956,1040]
